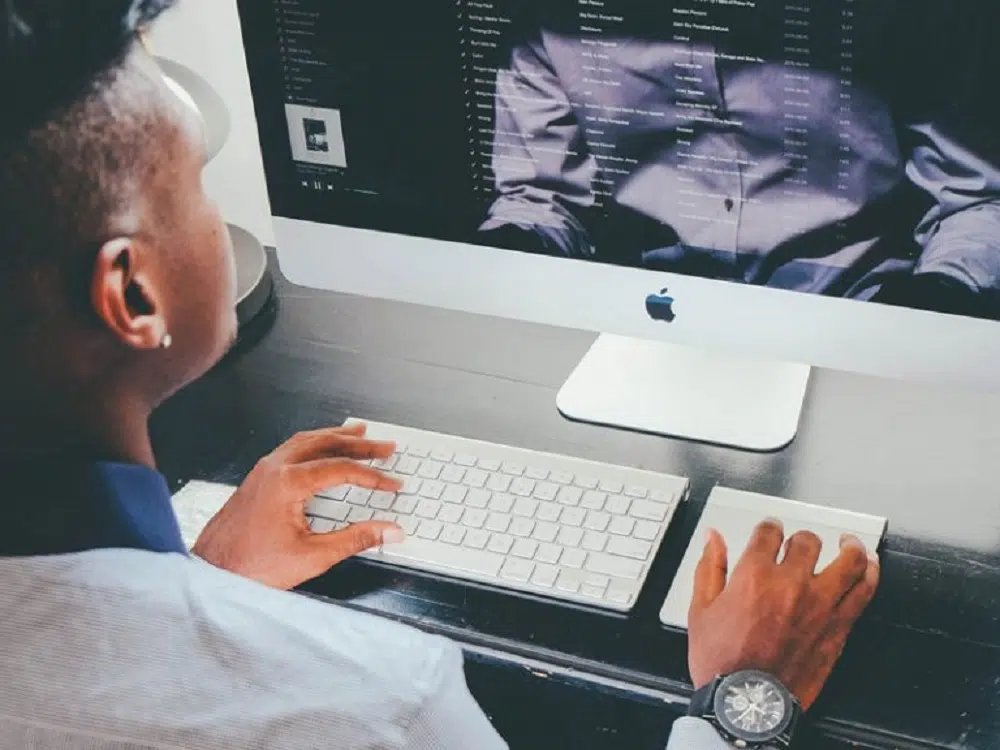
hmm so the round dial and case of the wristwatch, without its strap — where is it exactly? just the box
[715,672,794,742]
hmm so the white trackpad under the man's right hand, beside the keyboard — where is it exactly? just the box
[660,487,887,629]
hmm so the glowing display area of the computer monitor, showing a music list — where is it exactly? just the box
[241,0,1000,318]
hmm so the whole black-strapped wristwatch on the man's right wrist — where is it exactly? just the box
[688,670,802,750]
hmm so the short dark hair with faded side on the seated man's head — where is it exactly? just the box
[0,0,174,324]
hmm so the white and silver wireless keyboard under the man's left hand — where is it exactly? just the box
[306,420,688,612]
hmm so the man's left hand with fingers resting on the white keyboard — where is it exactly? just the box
[191,425,403,589]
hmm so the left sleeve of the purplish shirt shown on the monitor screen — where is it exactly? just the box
[481,30,597,258]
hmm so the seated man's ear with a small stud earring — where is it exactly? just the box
[90,237,167,350]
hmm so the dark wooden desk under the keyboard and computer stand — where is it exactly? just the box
[154,254,1000,750]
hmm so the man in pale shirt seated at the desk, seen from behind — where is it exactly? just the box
[0,0,878,750]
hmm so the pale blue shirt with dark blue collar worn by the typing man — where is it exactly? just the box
[0,465,726,750]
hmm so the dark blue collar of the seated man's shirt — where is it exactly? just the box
[0,462,187,557]
